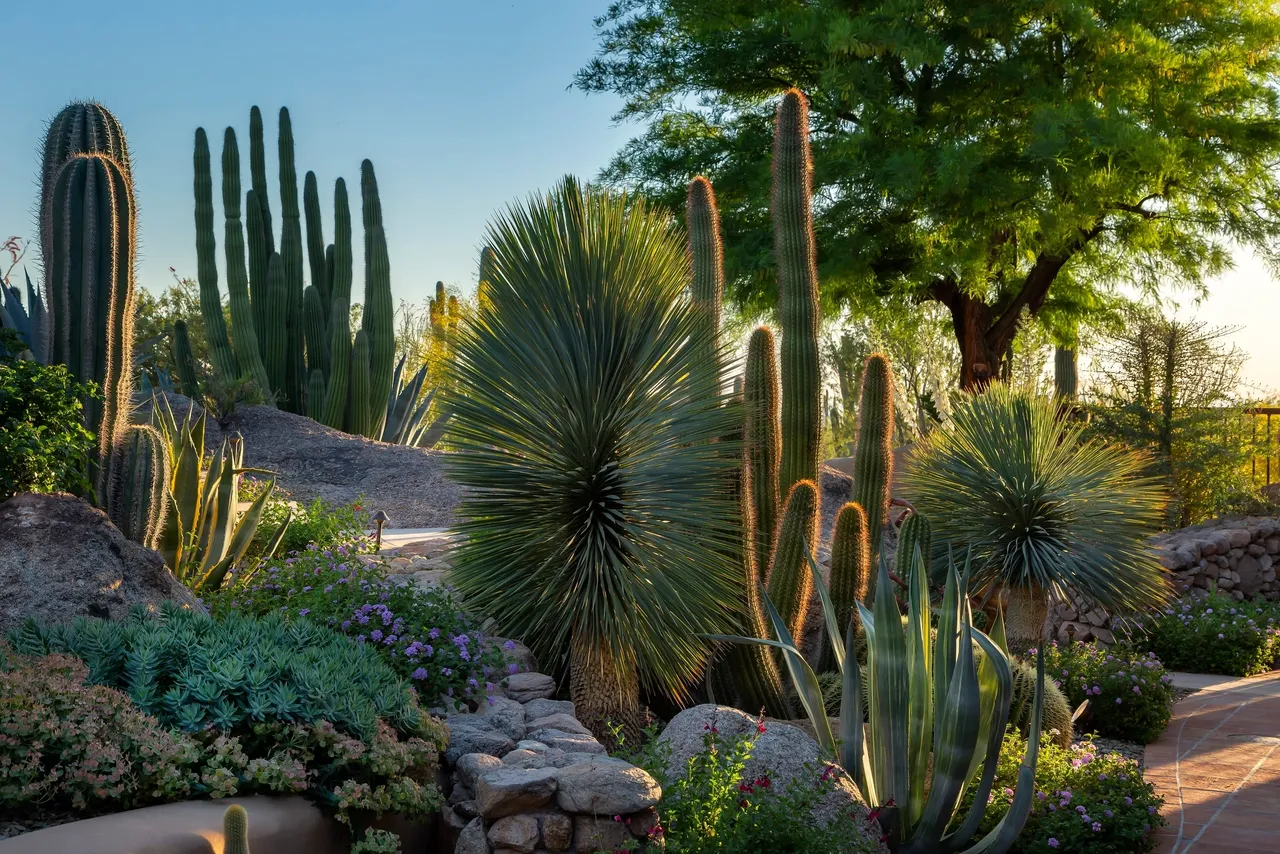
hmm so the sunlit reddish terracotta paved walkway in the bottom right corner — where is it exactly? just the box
[1144,675,1280,854]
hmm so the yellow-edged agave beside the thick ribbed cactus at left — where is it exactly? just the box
[151,397,292,593]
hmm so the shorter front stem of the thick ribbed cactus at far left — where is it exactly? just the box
[41,154,137,504]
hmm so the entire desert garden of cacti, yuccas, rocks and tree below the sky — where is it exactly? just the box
[0,0,1280,854]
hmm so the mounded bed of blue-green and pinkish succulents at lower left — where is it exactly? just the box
[0,606,447,839]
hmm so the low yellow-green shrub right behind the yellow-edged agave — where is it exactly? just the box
[241,478,369,558]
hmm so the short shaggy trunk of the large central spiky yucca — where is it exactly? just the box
[570,630,644,750]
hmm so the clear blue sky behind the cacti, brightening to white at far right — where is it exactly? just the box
[0,0,1280,391]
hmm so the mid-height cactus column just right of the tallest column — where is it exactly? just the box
[852,353,893,566]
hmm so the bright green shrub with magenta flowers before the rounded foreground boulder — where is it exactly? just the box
[623,721,882,854]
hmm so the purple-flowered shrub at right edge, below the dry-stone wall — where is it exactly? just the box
[1132,590,1280,676]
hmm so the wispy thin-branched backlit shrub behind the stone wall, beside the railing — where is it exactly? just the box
[1088,307,1270,528]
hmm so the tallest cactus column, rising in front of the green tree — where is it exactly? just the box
[772,90,822,501]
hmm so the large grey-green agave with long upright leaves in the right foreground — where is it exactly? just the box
[718,540,1044,854]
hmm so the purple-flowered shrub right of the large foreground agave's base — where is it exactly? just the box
[956,730,1165,854]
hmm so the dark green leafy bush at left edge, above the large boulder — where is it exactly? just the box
[0,359,96,501]
